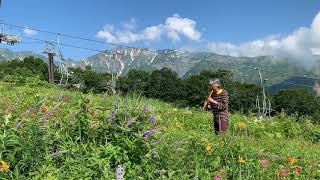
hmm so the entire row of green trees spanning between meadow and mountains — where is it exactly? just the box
[0,57,320,120]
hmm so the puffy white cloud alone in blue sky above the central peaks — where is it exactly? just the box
[96,14,201,44]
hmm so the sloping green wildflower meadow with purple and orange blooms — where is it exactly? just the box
[0,83,320,180]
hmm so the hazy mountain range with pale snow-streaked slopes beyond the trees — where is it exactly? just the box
[0,48,320,89]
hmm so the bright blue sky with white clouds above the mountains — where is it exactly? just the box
[0,0,320,60]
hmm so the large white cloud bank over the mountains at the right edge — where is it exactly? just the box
[208,12,320,60]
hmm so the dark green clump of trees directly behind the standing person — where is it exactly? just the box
[117,68,259,112]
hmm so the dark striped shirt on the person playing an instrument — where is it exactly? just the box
[211,90,229,118]
